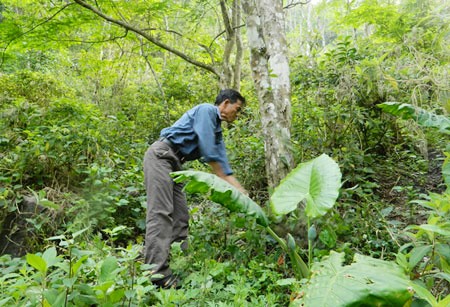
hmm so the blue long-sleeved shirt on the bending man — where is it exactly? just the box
[160,103,233,175]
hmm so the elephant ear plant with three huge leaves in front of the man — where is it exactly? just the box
[172,154,411,306]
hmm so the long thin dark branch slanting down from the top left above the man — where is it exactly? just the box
[73,0,219,76]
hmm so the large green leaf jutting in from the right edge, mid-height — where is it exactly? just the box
[378,102,450,134]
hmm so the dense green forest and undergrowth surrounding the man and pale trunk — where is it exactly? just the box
[0,0,450,306]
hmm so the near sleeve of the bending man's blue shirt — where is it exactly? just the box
[193,106,233,175]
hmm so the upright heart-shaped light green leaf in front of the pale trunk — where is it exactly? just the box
[270,154,342,218]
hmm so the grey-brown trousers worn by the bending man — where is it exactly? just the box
[144,141,189,276]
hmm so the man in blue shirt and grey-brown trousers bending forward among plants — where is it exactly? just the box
[144,89,247,288]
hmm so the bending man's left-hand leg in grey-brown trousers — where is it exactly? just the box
[144,143,174,277]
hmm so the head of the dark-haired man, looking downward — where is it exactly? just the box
[214,89,245,123]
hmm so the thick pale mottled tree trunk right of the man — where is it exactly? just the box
[242,0,293,188]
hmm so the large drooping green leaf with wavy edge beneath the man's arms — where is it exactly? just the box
[171,171,269,227]
